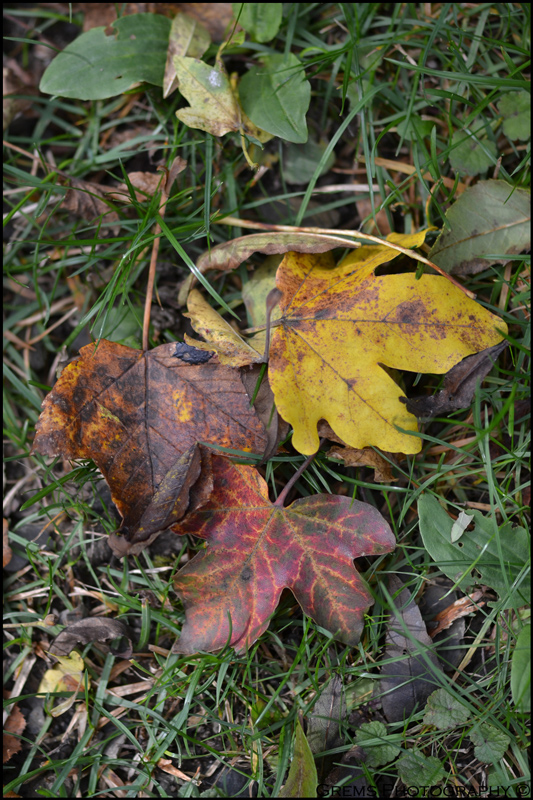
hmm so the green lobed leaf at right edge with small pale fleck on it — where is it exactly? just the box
[418,494,531,608]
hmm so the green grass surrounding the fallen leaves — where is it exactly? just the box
[4,3,530,797]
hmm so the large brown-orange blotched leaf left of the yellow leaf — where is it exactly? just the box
[33,340,267,556]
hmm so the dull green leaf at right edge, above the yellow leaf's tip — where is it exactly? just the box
[429,180,531,275]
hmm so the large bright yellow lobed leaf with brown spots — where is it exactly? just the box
[268,241,507,455]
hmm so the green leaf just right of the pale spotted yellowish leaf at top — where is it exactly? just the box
[239,53,311,144]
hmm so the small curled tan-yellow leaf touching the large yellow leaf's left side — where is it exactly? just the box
[183,289,263,367]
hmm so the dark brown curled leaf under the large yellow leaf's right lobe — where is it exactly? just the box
[400,342,507,419]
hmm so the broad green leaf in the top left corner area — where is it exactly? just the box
[39,14,170,100]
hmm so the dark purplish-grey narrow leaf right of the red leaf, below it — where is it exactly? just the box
[379,575,442,722]
